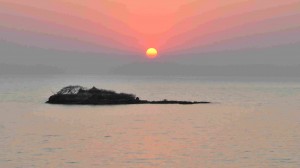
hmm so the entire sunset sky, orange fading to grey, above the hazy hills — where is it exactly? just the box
[0,0,300,76]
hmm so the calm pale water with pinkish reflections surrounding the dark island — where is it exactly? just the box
[0,76,300,168]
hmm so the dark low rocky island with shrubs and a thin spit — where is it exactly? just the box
[46,86,210,105]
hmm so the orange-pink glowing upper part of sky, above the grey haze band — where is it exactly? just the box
[0,0,300,56]
